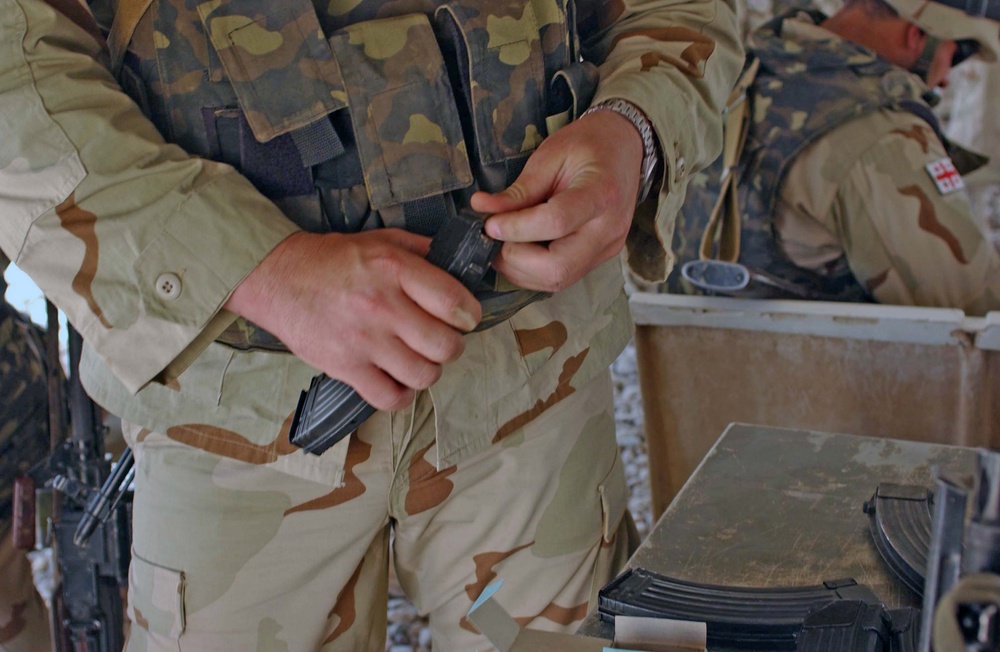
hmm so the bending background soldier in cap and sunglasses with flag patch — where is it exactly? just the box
[668,0,1000,314]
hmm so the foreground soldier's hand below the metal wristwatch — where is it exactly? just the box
[472,111,643,292]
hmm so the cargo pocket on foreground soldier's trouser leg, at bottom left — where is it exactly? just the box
[128,551,186,641]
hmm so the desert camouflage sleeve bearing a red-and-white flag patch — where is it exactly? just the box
[831,112,1000,315]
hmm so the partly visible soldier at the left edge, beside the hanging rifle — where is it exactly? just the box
[0,254,51,652]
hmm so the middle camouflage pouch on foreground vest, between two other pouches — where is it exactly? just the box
[330,14,472,210]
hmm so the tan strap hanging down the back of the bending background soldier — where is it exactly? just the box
[699,57,760,263]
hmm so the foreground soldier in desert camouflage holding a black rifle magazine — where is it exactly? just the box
[0,0,742,651]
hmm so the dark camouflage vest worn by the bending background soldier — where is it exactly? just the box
[666,11,940,302]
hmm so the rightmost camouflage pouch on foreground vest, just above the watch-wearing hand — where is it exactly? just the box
[434,0,546,192]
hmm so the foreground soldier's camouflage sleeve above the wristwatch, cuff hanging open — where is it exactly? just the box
[579,0,743,282]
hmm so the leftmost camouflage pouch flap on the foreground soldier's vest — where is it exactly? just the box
[198,0,346,142]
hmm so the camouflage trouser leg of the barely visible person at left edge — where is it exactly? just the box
[0,530,52,652]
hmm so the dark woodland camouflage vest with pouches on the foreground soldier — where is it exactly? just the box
[119,0,597,350]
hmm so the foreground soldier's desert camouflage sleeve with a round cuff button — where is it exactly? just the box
[0,0,295,392]
